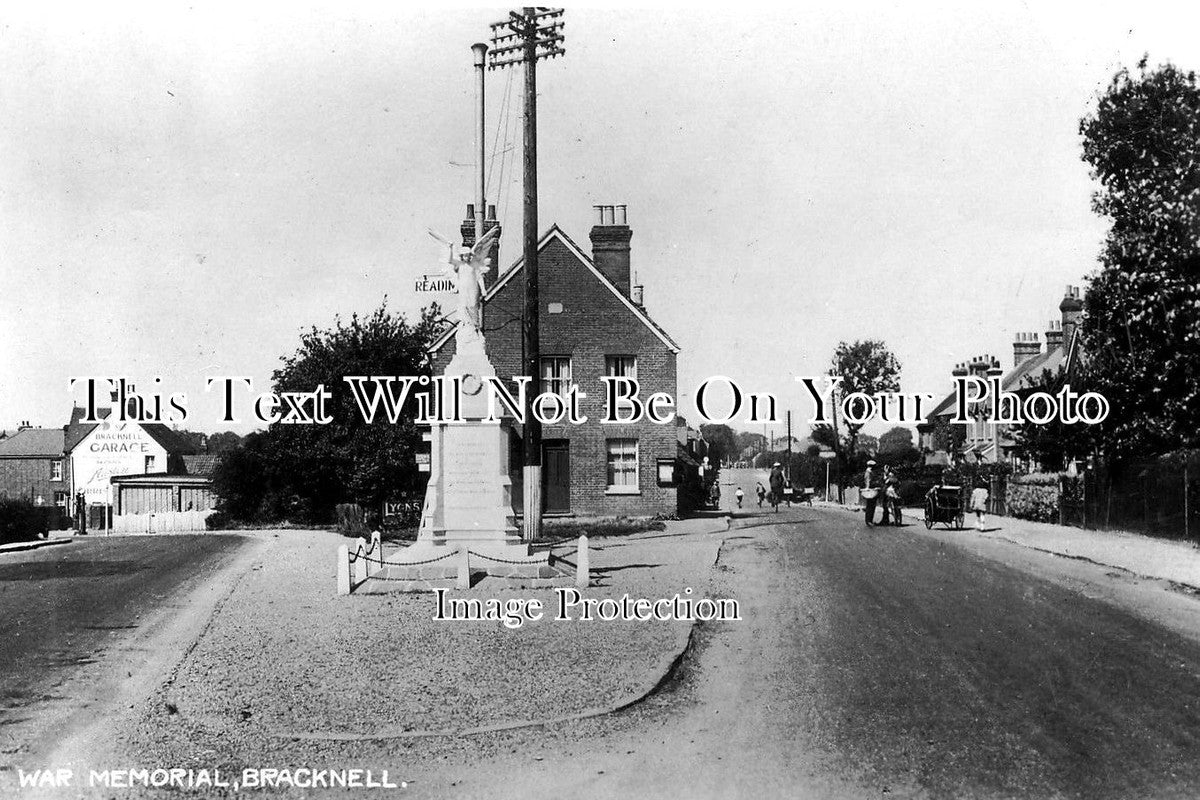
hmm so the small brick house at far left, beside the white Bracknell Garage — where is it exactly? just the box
[0,425,70,515]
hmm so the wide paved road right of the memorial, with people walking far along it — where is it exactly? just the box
[430,472,1200,798]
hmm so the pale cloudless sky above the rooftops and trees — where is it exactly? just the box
[0,2,1200,433]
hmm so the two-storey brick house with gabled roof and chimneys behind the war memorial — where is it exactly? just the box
[431,206,679,516]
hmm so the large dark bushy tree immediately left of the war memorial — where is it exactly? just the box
[214,302,440,522]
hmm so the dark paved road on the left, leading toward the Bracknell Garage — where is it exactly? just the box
[0,535,246,765]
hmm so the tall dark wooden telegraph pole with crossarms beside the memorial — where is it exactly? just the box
[488,6,566,542]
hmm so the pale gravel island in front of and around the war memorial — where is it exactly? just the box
[115,521,725,774]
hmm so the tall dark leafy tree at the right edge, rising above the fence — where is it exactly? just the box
[1079,58,1200,458]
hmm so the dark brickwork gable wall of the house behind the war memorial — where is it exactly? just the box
[433,230,678,516]
